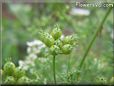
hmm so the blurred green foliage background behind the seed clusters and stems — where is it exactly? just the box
[2,3,114,83]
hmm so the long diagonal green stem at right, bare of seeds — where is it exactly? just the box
[79,7,112,69]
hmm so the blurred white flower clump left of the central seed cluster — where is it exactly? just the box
[19,40,46,70]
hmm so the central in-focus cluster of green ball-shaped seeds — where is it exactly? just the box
[39,25,77,55]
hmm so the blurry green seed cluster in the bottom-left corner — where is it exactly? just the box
[2,61,30,84]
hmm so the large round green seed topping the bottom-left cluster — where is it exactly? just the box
[3,62,15,76]
